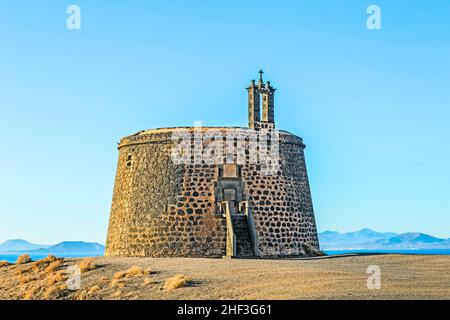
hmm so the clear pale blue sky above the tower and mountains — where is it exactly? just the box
[0,0,450,243]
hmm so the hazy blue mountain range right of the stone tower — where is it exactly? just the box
[319,229,450,250]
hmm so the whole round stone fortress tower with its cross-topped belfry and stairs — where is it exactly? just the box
[105,71,319,257]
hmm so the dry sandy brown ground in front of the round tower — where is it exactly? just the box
[0,255,450,299]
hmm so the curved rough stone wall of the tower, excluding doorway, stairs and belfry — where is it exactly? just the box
[105,128,319,257]
